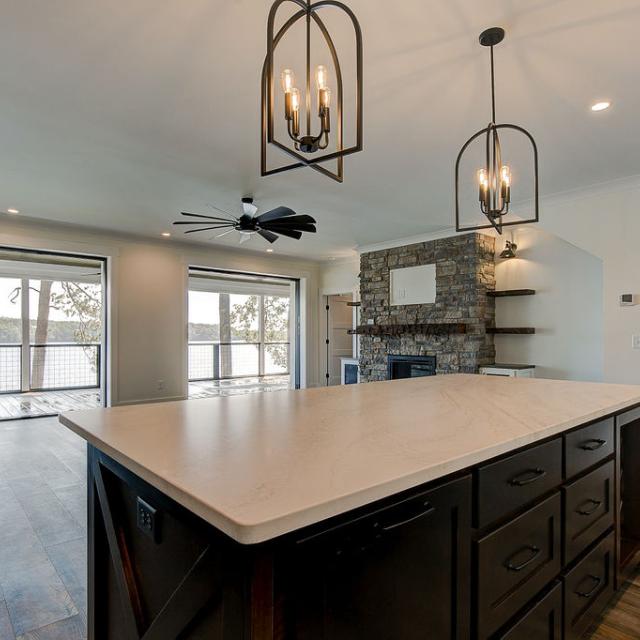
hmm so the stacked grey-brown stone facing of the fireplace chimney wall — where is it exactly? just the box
[360,234,495,382]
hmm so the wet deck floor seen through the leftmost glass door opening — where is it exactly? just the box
[0,389,102,420]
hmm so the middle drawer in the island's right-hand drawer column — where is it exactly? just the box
[563,460,615,564]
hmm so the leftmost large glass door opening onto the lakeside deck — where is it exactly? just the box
[0,250,104,419]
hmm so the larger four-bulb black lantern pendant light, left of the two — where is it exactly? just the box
[261,0,362,182]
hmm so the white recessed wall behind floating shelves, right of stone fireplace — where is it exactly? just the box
[495,225,604,381]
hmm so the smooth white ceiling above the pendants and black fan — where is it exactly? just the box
[0,0,640,259]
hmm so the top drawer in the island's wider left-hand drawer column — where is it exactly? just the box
[477,438,562,527]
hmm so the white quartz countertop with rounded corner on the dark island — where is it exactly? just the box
[60,375,640,544]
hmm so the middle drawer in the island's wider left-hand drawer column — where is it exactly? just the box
[477,493,562,638]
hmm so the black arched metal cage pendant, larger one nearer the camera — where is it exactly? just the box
[260,0,363,182]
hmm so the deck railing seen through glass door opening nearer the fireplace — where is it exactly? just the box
[189,342,289,382]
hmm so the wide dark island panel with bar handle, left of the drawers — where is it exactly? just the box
[282,477,471,640]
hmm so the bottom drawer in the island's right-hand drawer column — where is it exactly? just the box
[564,533,614,640]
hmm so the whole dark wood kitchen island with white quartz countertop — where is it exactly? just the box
[61,375,640,640]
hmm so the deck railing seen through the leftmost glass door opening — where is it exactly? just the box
[0,342,101,393]
